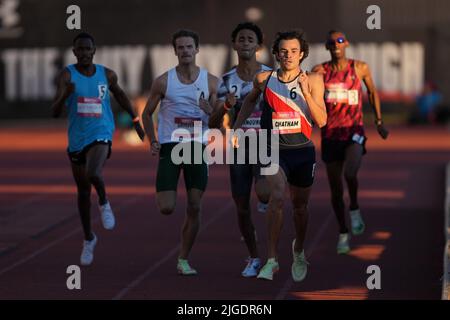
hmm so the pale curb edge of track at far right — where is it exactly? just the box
[442,162,450,300]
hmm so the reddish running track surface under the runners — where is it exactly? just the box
[0,127,450,300]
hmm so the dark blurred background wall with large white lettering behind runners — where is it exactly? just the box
[0,0,450,121]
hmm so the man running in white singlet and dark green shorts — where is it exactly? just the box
[143,30,218,275]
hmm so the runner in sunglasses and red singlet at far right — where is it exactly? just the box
[313,30,389,254]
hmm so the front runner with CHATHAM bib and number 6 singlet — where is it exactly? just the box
[233,30,327,281]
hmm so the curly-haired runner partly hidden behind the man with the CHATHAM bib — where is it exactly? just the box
[209,22,270,277]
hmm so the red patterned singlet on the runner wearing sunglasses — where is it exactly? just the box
[322,59,364,140]
